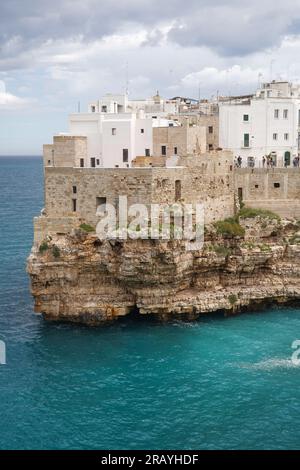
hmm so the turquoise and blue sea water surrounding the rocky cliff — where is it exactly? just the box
[0,157,300,449]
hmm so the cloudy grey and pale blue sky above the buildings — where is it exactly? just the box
[0,0,300,155]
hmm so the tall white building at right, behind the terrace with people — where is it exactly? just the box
[219,81,300,166]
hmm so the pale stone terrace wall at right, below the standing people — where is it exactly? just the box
[235,168,300,218]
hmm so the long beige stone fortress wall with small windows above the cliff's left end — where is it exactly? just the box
[40,154,234,239]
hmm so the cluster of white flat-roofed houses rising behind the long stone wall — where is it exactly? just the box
[70,93,178,168]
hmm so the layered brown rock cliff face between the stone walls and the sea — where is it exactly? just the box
[27,218,300,325]
